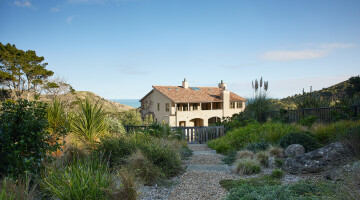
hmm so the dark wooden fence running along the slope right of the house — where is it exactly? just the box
[264,105,360,123]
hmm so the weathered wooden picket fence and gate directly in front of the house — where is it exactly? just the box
[124,125,225,144]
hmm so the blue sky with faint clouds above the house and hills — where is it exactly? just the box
[0,0,360,99]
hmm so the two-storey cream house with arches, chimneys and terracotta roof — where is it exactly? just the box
[140,79,247,127]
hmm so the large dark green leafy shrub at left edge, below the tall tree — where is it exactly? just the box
[0,100,60,177]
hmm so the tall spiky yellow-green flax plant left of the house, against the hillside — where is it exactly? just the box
[71,99,107,146]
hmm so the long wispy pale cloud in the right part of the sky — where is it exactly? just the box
[262,43,356,61]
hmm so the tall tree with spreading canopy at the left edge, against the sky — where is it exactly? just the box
[0,43,54,99]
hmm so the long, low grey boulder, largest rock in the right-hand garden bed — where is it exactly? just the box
[283,142,350,174]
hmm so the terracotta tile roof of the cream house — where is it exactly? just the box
[153,86,247,102]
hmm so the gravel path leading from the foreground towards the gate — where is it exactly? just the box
[168,144,238,200]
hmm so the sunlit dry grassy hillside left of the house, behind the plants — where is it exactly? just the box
[40,91,134,113]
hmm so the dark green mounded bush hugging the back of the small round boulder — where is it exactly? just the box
[279,132,320,152]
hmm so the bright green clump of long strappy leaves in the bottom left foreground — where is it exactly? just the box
[40,156,118,200]
